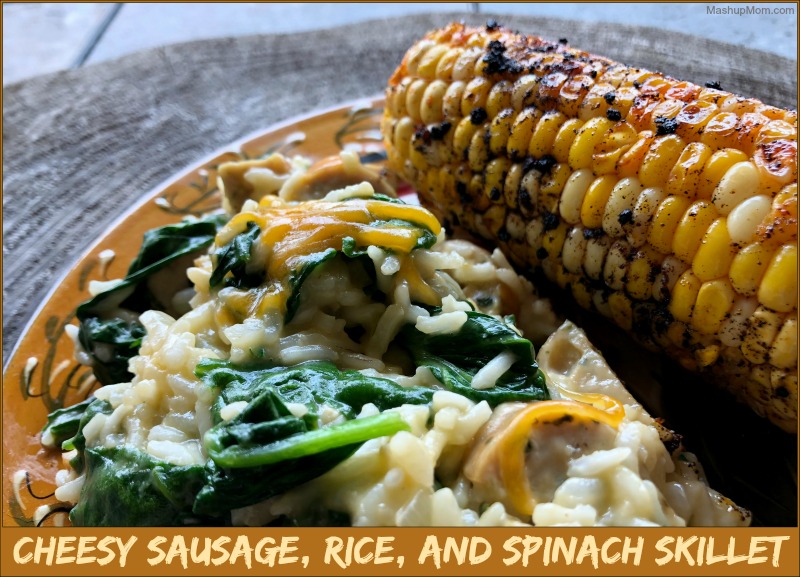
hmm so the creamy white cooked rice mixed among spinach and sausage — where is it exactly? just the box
[57,154,752,526]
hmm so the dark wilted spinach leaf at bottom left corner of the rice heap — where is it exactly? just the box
[70,447,213,527]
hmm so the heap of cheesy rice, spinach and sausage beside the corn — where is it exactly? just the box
[42,153,750,526]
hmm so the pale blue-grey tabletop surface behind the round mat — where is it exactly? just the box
[3,2,798,85]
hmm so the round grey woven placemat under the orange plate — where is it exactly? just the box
[3,13,797,359]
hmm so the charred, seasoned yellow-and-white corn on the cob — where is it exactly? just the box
[382,24,797,431]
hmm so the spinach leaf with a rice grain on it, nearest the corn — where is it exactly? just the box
[399,311,549,407]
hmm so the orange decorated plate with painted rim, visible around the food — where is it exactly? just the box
[3,98,797,526]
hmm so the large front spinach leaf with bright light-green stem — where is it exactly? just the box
[187,359,418,515]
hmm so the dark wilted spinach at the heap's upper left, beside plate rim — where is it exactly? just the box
[76,215,225,385]
